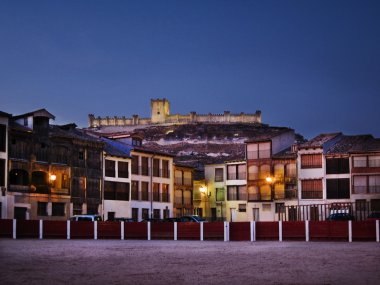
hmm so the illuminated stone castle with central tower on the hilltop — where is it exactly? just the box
[88,98,261,128]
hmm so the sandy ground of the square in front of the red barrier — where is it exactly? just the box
[0,239,380,285]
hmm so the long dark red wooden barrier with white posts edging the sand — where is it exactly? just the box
[0,219,380,242]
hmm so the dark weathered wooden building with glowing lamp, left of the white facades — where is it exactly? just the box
[5,109,103,220]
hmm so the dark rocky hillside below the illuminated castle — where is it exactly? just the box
[92,123,304,167]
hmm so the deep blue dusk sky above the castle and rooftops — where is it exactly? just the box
[0,0,380,139]
